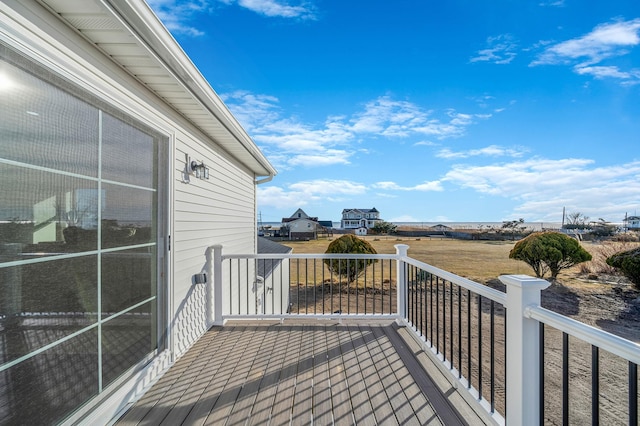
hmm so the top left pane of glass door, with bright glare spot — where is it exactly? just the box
[0,60,98,177]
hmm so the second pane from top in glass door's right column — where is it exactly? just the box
[102,183,157,248]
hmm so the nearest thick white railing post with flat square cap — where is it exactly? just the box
[500,275,550,426]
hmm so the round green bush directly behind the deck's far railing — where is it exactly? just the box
[324,234,378,283]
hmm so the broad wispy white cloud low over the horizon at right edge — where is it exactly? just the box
[442,158,640,221]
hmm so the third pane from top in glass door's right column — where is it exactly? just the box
[102,246,157,317]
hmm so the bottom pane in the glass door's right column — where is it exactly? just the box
[102,301,157,386]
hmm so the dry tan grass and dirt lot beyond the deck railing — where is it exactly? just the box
[283,236,640,425]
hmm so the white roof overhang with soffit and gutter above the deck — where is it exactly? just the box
[40,0,277,177]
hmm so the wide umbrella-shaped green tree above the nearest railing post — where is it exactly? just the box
[509,232,591,280]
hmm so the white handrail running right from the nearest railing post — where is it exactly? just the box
[525,306,640,364]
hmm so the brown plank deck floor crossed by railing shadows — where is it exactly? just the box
[116,321,475,426]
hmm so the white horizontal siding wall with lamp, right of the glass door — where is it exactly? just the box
[173,134,256,355]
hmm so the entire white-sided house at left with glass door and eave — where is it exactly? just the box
[0,0,276,424]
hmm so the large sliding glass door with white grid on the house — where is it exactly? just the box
[0,46,167,424]
